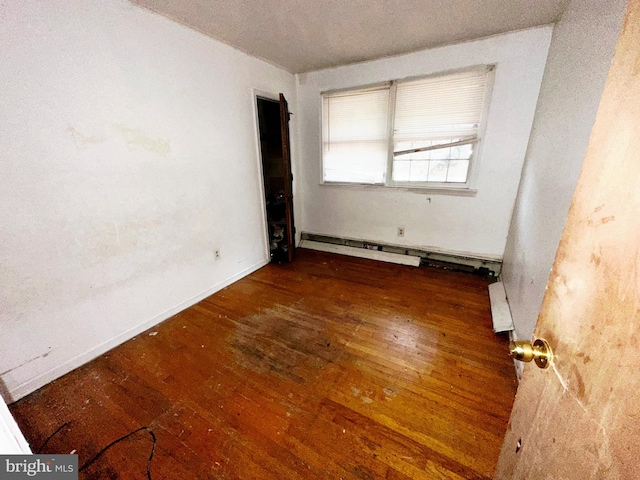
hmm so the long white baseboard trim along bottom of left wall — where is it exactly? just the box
[4,258,270,403]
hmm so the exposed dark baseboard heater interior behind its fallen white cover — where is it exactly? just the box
[300,232,502,277]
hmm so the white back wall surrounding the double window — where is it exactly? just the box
[296,26,552,259]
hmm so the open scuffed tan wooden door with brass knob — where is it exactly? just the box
[496,0,640,479]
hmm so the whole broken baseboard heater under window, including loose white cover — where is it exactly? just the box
[299,232,502,277]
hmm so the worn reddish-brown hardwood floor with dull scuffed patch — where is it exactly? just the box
[11,250,516,480]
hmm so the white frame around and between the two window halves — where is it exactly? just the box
[320,64,497,196]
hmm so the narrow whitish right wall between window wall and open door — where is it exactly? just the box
[502,0,626,339]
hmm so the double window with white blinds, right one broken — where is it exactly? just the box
[322,66,493,188]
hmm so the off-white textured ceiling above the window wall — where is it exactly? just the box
[131,0,569,73]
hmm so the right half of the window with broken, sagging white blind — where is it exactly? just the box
[392,67,489,183]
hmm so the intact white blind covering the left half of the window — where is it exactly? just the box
[322,86,389,184]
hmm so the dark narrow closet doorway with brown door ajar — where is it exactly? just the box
[256,94,295,263]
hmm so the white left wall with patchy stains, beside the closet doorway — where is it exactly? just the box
[0,0,299,399]
